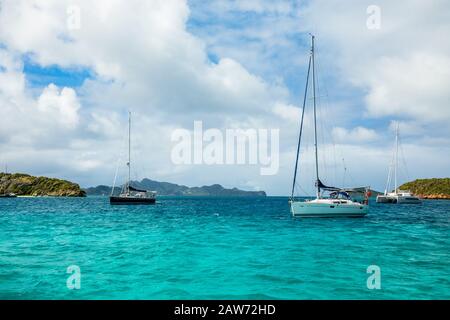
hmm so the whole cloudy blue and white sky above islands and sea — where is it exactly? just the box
[0,0,450,195]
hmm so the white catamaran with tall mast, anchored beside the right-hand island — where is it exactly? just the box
[377,123,422,204]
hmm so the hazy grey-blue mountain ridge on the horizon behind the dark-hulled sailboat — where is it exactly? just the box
[84,178,266,197]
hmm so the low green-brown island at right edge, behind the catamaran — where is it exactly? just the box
[399,178,450,200]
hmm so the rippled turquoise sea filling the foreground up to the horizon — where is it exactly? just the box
[0,197,450,299]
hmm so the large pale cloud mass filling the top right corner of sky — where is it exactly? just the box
[302,0,450,125]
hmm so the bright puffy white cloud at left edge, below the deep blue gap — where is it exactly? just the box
[0,49,80,147]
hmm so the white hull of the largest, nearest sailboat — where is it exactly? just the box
[291,201,369,218]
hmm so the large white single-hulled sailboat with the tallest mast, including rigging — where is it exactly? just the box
[289,35,369,218]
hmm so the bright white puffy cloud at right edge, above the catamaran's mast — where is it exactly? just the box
[367,52,450,122]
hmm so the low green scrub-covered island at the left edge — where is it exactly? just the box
[0,173,86,197]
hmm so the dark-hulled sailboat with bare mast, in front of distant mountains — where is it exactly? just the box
[109,112,156,204]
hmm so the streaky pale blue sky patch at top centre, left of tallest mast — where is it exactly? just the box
[187,1,310,99]
